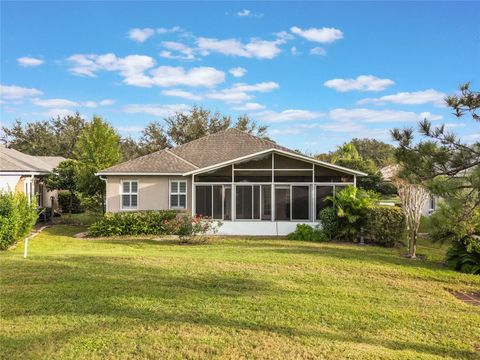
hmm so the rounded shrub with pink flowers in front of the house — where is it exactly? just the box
[169,215,221,243]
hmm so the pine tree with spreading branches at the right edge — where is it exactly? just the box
[392,83,480,264]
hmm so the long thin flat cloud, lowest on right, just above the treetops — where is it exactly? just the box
[328,108,442,123]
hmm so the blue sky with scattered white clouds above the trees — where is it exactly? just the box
[0,2,480,152]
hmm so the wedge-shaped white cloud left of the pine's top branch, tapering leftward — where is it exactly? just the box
[357,89,447,107]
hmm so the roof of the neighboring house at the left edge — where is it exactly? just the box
[0,145,65,173]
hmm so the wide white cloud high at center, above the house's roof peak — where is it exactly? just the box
[197,37,285,59]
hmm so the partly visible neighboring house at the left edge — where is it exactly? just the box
[0,145,65,207]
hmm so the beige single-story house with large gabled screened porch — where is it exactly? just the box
[97,129,366,235]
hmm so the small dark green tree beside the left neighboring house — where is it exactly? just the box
[46,159,78,213]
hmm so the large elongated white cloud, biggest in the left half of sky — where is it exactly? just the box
[67,54,225,87]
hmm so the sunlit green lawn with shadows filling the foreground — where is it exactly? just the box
[0,226,480,359]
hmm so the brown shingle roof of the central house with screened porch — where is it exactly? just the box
[100,128,294,174]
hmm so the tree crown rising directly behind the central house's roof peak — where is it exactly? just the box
[165,106,267,145]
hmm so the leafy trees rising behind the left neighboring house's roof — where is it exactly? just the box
[1,113,85,158]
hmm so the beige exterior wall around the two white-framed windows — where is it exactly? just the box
[106,175,192,213]
